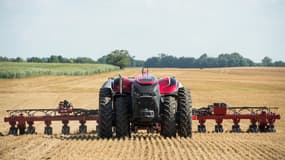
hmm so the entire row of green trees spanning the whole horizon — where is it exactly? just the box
[0,49,285,69]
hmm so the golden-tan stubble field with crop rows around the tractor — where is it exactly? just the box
[0,68,285,160]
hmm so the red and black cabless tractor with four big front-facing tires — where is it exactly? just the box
[98,69,192,138]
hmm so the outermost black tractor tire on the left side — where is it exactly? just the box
[98,88,113,138]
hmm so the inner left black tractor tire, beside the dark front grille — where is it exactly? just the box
[115,96,130,138]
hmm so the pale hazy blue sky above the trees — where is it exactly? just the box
[0,0,285,62]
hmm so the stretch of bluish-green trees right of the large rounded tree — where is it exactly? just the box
[144,52,285,68]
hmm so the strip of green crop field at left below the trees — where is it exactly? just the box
[0,62,119,79]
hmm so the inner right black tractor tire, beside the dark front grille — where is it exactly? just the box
[160,96,177,137]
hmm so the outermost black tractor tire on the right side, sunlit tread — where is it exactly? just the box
[177,88,192,137]
